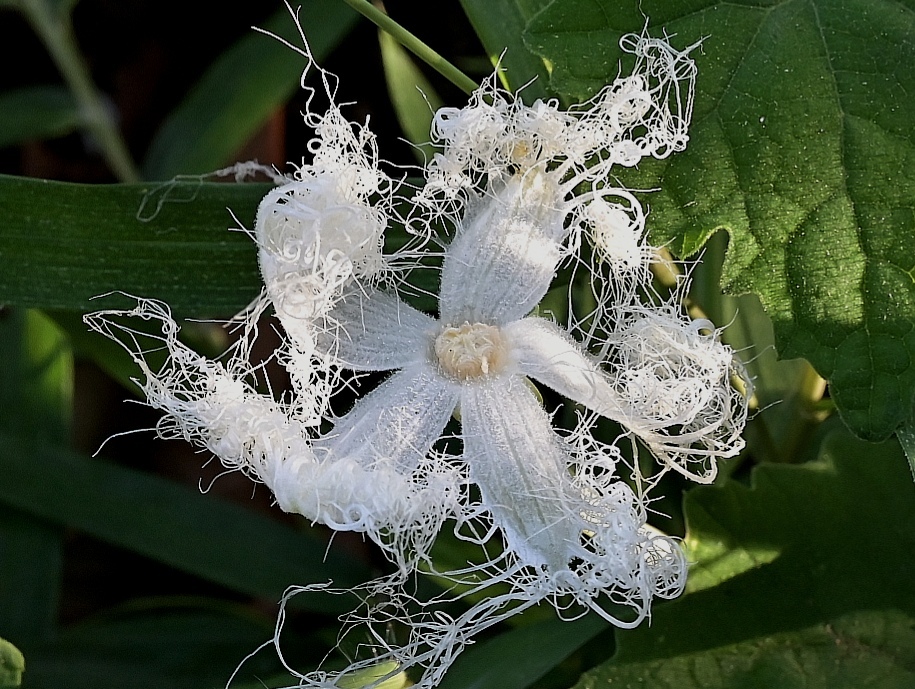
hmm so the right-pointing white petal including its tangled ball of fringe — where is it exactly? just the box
[503,310,750,483]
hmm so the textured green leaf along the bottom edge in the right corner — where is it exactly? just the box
[576,610,915,689]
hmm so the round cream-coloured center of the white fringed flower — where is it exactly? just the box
[434,321,507,380]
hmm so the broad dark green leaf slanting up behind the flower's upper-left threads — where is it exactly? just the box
[143,0,358,179]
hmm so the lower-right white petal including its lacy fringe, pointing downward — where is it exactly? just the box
[461,376,686,627]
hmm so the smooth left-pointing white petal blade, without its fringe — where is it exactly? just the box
[317,290,438,371]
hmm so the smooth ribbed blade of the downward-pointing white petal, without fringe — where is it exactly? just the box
[461,376,581,572]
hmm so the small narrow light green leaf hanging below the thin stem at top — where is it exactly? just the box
[378,31,442,162]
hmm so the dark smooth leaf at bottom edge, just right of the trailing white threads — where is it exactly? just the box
[439,614,609,689]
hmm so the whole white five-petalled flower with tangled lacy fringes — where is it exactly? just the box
[87,12,746,689]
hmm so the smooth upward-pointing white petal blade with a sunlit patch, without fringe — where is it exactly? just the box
[439,174,565,325]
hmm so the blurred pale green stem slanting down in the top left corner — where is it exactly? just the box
[18,0,140,182]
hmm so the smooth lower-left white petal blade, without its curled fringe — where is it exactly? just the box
[314,362,460,475]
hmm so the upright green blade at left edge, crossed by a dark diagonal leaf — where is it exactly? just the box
[0,310,73,646]
